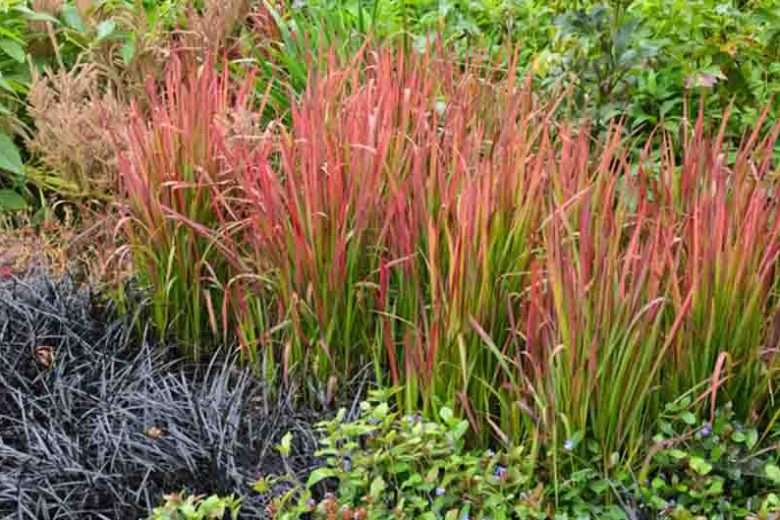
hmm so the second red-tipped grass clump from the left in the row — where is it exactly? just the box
[243,46,424,379]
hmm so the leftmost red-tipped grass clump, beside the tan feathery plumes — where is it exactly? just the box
[119,55,250,357]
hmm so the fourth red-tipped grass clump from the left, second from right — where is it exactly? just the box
[526,125,673,464]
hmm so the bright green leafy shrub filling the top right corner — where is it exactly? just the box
[628,0,780,134]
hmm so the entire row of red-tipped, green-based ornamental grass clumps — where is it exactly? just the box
[120,44,780,467]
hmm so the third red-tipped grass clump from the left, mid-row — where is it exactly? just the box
[383,57,545,430]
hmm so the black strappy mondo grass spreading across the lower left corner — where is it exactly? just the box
[0,273,321,519]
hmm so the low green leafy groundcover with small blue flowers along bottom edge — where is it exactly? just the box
[264,392,780,520]
